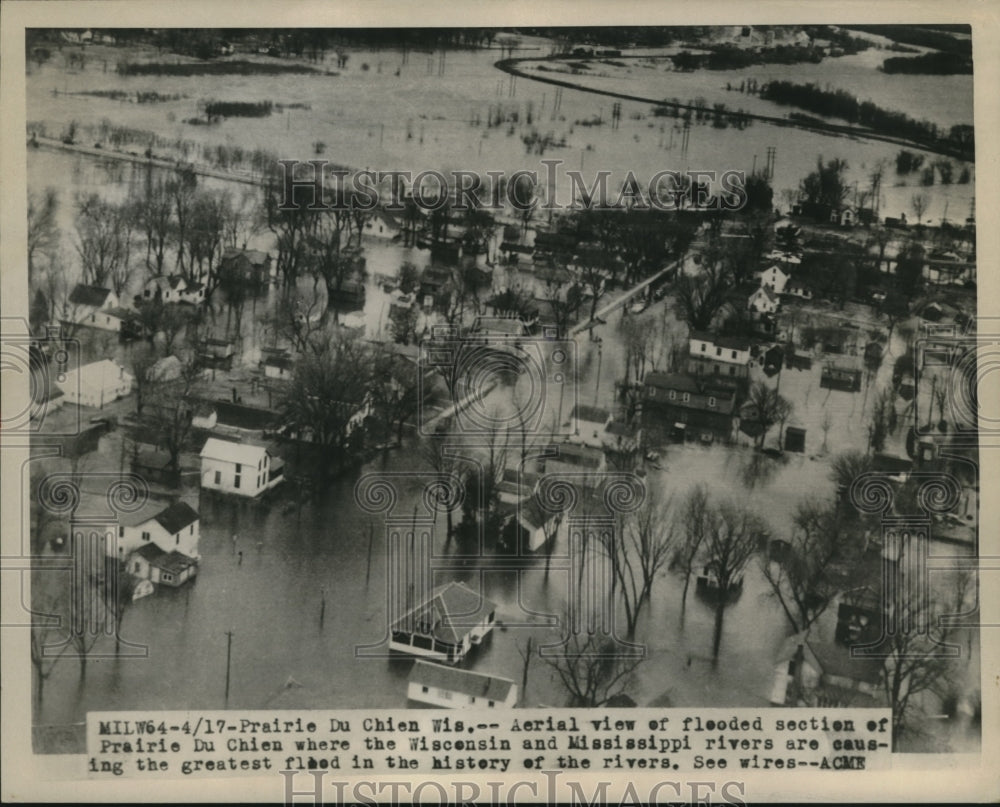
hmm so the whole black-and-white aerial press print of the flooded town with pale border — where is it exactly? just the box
[2,4,1000,803]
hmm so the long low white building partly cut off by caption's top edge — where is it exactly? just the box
[406,659,517,709]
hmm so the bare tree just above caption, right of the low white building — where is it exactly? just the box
[542,632,643,707]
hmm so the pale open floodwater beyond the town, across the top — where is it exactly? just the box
[26,38,974,222]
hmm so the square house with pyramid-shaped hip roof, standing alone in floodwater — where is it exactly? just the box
[389,580,496,664]
